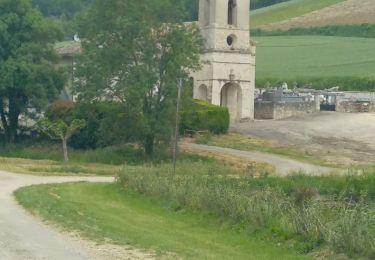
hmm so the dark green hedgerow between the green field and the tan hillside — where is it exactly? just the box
[251,24,375,38]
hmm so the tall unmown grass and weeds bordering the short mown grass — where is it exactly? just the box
[118,163,375,258]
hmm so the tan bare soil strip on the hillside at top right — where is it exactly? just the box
[260,0,375,30]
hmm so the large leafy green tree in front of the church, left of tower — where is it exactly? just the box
[76,0,203,158]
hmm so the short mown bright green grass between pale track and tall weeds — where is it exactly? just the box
[16,183,308,259]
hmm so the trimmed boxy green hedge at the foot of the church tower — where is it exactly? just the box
[180,100,229,134]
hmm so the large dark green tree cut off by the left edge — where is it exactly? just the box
[0,0,64,142]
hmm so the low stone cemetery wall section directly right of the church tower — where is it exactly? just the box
[255,101,319,120]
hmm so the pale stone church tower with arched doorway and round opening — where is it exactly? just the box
[193,0,255,122]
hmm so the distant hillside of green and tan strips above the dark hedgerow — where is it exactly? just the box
[251,0,375,30]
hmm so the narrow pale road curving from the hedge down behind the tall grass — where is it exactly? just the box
[183,143,335,175]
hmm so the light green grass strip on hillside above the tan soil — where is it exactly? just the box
[250,0,344,28]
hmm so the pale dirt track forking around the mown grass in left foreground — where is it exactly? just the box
[0,171,154,260]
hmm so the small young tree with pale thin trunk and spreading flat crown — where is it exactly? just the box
[36,119,86,162]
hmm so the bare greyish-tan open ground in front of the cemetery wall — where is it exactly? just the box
[232,112,375,166]
